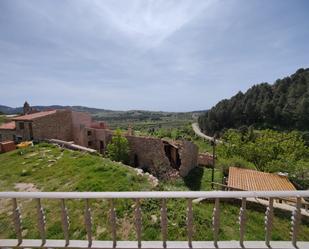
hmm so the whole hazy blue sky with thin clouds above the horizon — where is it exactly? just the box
[0,0,309,111]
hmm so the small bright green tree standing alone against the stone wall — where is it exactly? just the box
[107,129,129,164]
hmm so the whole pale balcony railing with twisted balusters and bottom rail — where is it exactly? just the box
[0,191,309,249]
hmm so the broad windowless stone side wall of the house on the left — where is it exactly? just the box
[32,110,73,141]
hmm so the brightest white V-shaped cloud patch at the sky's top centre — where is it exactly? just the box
[91,0,214,46]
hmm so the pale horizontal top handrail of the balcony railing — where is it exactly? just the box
[0,190,309,199]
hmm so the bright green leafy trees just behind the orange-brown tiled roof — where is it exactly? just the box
[218,130,309,178]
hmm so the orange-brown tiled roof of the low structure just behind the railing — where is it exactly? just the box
[228,167,296,191]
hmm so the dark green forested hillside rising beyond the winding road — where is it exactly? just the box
[199,68,309,135]
